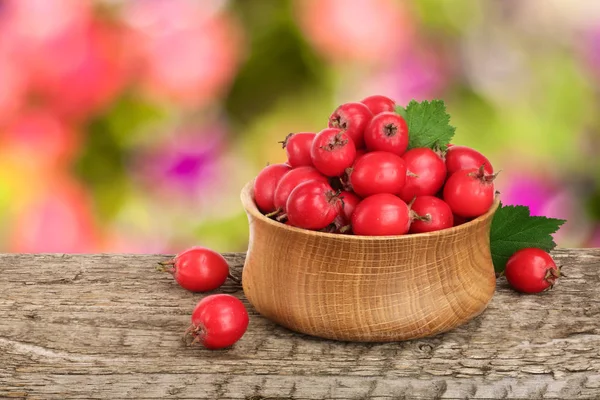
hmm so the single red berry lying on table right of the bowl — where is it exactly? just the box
[504,248,560,293]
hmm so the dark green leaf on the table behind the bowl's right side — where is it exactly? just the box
[490,204,566,273]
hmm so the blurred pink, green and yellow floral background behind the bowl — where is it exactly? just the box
[0,0,600,253]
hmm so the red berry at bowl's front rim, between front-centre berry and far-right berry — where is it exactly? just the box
[410,196,454,233]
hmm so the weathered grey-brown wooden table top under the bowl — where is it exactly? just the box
[0,249,600,400]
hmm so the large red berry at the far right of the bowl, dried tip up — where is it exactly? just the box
[444,168,495,218]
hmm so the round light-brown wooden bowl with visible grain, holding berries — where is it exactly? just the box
[241,182,499,342]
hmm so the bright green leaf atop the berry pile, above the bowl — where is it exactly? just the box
[396,100,456,149]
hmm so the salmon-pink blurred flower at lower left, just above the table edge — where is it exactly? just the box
[10,180,98,253]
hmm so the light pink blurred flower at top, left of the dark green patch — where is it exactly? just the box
[124,0,242,107]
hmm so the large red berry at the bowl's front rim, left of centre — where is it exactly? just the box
[286,181,341,230]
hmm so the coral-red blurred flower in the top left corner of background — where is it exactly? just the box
[3,0,125,119]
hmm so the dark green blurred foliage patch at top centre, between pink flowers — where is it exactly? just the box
[225,0,327,126]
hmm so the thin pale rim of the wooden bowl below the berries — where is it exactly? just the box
[240,179,500,241]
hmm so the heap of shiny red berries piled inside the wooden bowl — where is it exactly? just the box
[254,95,496,236]
